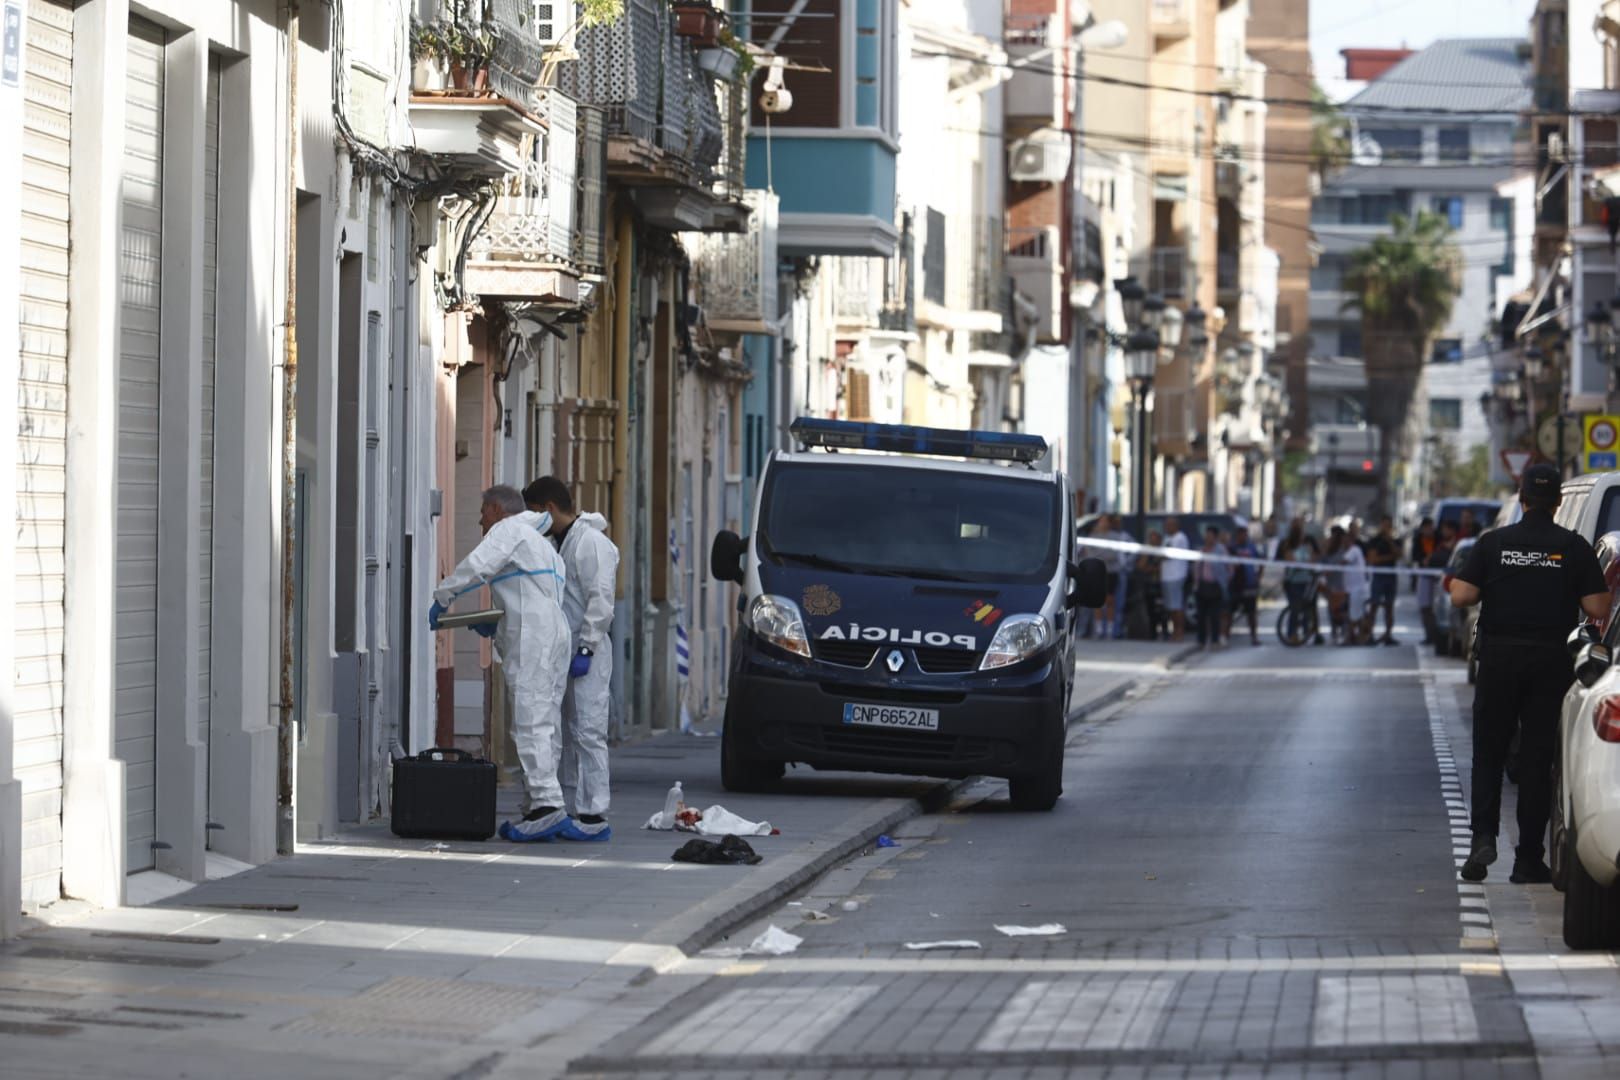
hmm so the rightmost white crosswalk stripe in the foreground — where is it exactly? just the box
[1311,975,1479,1046]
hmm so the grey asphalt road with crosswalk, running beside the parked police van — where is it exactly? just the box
[575,628,1548,1078]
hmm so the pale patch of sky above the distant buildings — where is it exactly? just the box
[1311,0,1536,86]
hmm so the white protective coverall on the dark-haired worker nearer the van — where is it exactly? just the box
[550,513,619,814]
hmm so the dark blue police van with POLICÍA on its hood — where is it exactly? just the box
[710,418,1106,810]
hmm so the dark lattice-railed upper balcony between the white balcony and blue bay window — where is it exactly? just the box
[557,0,741,232]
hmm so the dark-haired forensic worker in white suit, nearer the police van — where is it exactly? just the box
[523,476,619,840]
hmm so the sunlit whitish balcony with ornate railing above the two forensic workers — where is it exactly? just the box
[465,91,601,306]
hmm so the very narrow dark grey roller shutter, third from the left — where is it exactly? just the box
[198,57,220,819]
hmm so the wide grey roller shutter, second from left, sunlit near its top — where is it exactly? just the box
[115,19,164,873]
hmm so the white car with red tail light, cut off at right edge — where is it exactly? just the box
[1547,533,1620,949]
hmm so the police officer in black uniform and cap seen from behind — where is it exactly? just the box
[1452,465,1609,884]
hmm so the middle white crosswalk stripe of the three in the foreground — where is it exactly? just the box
[978,976,1176,1052]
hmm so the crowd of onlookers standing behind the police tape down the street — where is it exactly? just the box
[1082,512,1481,648]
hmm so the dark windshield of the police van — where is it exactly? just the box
[758,461,1063,585]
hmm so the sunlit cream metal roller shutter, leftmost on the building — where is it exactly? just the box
[13,0,73,904]
